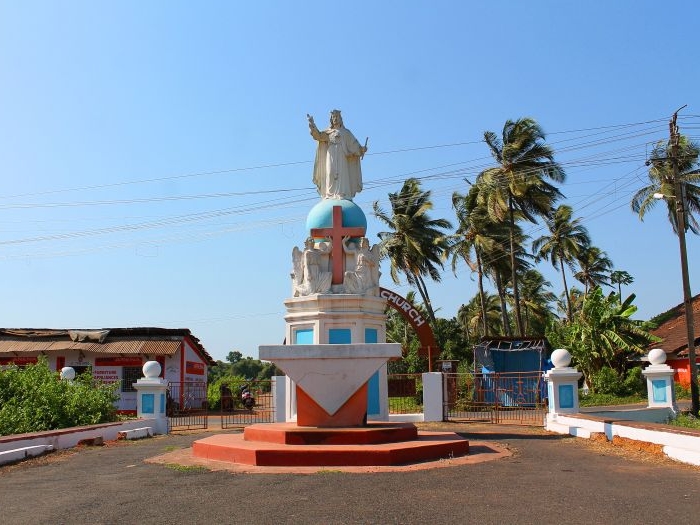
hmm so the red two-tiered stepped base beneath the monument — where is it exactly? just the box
[192,423,469,467]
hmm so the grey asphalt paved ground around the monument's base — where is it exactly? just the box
[0,423,700,525]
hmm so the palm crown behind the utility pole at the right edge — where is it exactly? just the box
[631,135,700,235]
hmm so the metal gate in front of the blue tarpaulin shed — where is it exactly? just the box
[443,372,547,425]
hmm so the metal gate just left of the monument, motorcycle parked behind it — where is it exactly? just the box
[221,379,275,429]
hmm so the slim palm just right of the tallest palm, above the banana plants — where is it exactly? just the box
[532,204,591,322]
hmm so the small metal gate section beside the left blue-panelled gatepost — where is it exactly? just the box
[165,381,208,432]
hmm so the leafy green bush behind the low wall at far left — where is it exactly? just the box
[0,358,119,436]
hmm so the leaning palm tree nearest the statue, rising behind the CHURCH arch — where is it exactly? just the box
[373,178,452,327]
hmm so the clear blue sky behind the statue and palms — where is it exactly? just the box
[0,0,700,359]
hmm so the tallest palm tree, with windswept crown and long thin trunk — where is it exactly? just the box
[477,118,565,336]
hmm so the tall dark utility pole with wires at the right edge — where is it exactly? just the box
[668,106,700,417]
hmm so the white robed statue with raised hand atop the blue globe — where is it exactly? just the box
[306,109,367,200]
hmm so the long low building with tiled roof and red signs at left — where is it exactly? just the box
[0,327,214,413]
